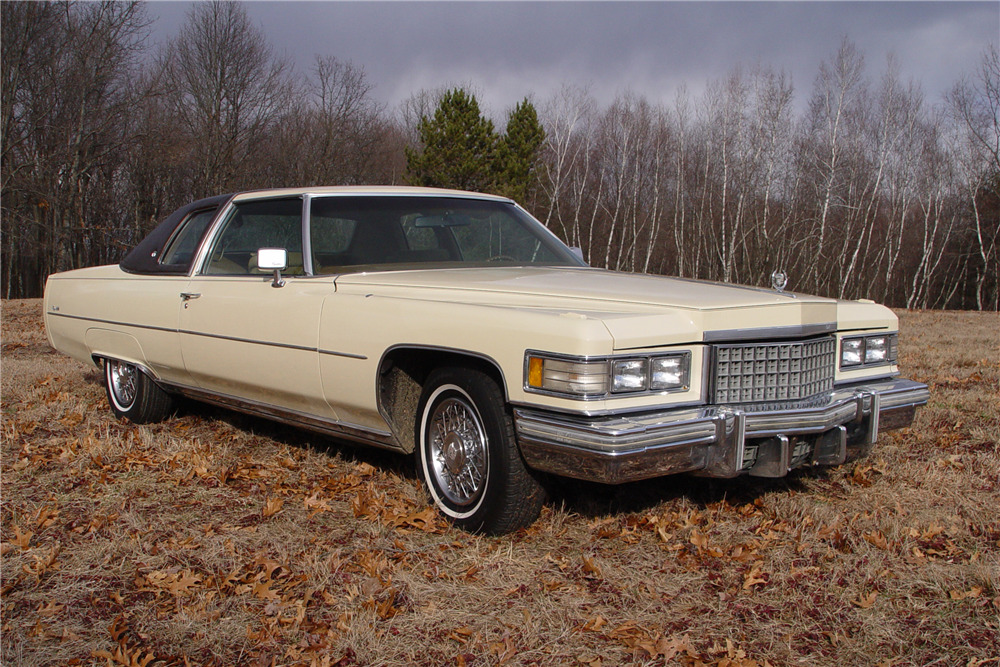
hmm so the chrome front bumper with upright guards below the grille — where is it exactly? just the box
[514,379,930,484]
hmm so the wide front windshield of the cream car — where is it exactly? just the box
[310,197,582,274]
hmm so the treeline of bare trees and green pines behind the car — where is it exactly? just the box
[0,2,1000,310]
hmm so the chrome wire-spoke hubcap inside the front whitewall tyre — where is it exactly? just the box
[428,398,487,506]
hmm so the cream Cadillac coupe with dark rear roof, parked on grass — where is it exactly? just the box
[44,188,928,534]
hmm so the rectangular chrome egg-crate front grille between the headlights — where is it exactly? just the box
[712,336,837,404]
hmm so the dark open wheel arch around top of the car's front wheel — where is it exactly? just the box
[377,344,510,454]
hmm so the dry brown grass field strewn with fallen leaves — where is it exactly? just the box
[0,300,1000,667]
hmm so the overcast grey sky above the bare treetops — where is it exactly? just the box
[148,0,1000,118]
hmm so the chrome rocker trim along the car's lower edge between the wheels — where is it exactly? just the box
[158,382,403,451]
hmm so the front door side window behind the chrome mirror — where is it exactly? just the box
[204,199,304,275]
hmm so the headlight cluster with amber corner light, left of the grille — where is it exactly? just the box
[524,352,691,398]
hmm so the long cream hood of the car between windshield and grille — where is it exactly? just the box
[337,267,860,350]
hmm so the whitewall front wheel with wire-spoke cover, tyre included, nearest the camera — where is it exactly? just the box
[417,368,545,535]
